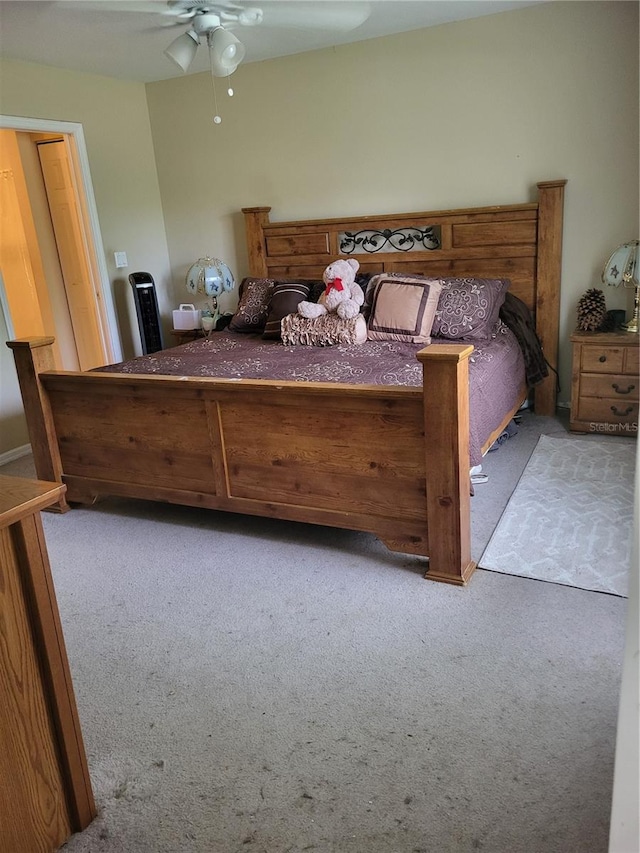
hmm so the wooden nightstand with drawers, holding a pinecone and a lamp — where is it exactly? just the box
[569,332,639,436]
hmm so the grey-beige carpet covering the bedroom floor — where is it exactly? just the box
[0,415,626,853]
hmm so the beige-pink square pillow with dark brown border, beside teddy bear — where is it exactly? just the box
[367,273,441,344]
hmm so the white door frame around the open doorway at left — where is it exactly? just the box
[0,115,122,363]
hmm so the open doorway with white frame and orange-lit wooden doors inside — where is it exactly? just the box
[0,116,121,370]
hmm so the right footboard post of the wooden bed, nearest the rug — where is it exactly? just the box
[418,344,476,586]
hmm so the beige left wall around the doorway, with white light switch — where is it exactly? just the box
[0,61,173,454]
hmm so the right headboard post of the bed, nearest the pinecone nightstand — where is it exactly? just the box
[534,180,567,415]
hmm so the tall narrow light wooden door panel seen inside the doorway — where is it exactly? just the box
[38,140,104,370]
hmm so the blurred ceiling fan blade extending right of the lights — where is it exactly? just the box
[249,0,371,32]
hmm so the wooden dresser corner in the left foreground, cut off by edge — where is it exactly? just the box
[0,475,95,853]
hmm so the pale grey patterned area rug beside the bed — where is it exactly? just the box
[480,435,636,597]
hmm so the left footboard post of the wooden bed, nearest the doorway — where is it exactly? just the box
[7,338,69,512]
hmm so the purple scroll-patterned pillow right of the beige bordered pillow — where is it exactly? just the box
[431,278,510,341]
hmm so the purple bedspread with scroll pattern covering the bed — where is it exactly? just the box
[98,322,524,465]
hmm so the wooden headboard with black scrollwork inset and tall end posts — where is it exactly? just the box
[242,180,566,415]
